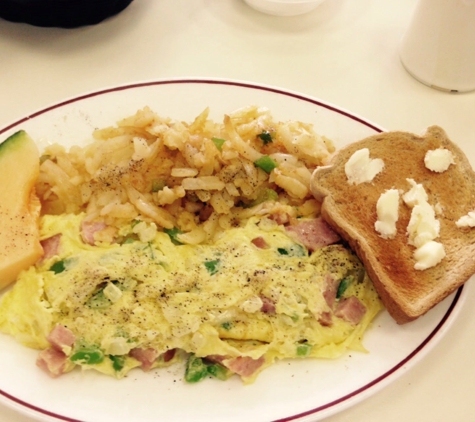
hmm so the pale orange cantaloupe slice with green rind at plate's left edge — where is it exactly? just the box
[0,131,43,289]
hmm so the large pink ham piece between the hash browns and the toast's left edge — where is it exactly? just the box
[285,217,340,251]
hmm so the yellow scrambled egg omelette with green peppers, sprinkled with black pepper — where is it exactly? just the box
[0,215,381,382]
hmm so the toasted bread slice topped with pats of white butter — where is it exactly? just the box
[311,126,475,324]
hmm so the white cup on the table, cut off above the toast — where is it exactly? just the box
[399,0,475,92]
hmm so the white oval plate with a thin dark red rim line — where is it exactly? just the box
[0,79,466,422]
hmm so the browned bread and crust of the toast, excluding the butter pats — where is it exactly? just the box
[311,126,475,324]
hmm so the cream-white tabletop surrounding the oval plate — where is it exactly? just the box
[0,0,475,422]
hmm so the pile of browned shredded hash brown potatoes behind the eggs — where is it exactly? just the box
[36,106,334,244]
